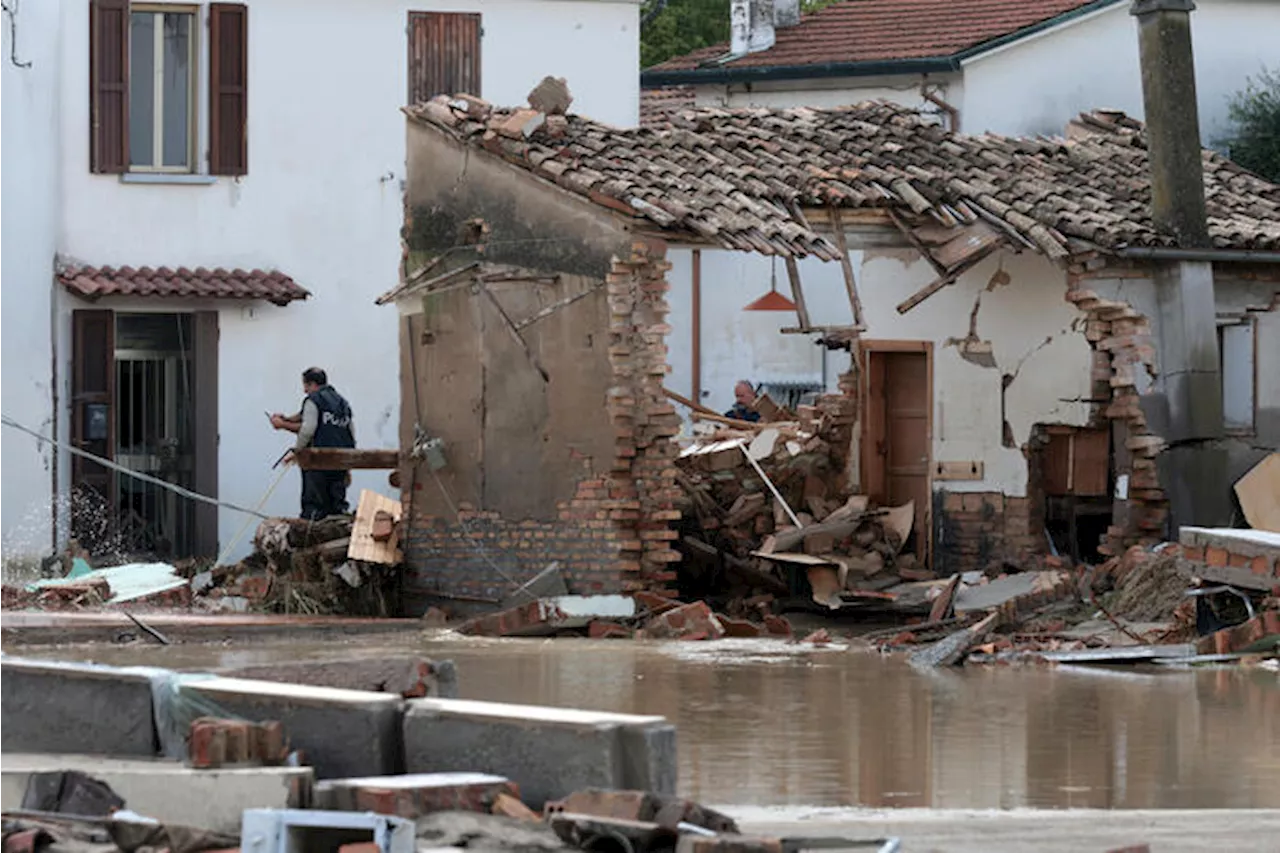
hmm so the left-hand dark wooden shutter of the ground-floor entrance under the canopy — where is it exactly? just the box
[72,311,115,547]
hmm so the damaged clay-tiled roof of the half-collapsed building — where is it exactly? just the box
[406,96,1280,259]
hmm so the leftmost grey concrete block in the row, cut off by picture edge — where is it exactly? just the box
[0,657,157,757]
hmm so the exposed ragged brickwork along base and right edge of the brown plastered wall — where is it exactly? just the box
[404,241,680,612]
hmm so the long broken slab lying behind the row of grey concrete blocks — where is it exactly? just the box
[218,654,458,699]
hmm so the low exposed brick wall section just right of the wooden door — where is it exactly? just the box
[933,492,1041,576]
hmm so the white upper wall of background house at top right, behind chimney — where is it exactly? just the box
[961,0,1280,145]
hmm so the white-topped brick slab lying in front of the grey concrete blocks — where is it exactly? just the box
[316,772,520,820]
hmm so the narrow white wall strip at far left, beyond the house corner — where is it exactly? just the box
[0,1,59,573]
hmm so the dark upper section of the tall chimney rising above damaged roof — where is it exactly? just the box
[1129,0,1210,248]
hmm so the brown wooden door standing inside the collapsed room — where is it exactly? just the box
[863,345,932,564]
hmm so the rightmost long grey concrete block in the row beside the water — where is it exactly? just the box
[404,699,676,808]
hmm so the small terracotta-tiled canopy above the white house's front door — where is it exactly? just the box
[58,266,310,305]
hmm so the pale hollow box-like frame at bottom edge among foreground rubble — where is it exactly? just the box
[241,808,416,853]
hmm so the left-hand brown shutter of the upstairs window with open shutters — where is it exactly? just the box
[88,0,129,174]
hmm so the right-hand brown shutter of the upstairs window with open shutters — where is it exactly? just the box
[209,3,248,174]
